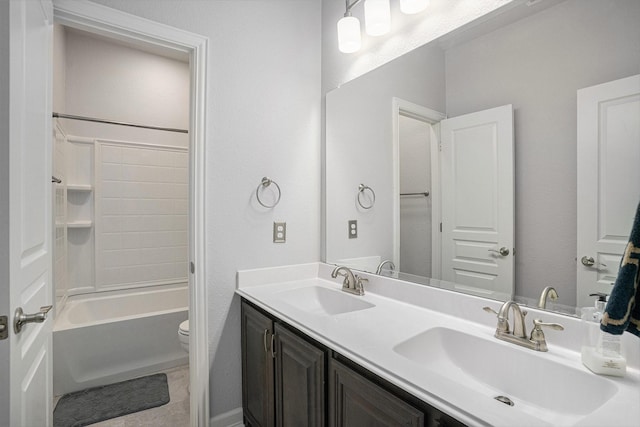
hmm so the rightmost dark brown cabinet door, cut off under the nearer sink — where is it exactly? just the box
[329,359,424,427]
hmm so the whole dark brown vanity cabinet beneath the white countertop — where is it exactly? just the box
[242,300,464,427]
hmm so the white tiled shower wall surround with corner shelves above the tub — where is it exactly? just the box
[54,130,189,300]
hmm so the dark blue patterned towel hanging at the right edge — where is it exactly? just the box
[600,204,640,337]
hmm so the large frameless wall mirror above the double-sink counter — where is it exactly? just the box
[325,0,640,312]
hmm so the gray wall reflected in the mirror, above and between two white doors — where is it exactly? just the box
[446,0,640,305]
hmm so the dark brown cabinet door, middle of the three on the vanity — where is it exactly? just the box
[275,324,324,427]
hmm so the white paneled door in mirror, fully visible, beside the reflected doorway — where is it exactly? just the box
[441,105,514,298]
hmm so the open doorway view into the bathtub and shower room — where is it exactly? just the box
[52,25,190,425]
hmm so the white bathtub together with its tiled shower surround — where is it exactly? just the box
[53,132,189,395]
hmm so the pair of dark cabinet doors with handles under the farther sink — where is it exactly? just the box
[242,301,326,427]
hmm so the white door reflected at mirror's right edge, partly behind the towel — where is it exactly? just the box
[576,75,640,307]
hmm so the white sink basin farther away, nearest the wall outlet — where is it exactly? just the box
[279,286,375,316]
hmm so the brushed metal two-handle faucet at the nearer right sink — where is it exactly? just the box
[483,301,564,351]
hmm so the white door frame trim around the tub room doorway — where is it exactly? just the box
[54,2,209,425]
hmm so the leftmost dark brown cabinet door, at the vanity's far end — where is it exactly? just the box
[242,302,275,427]
